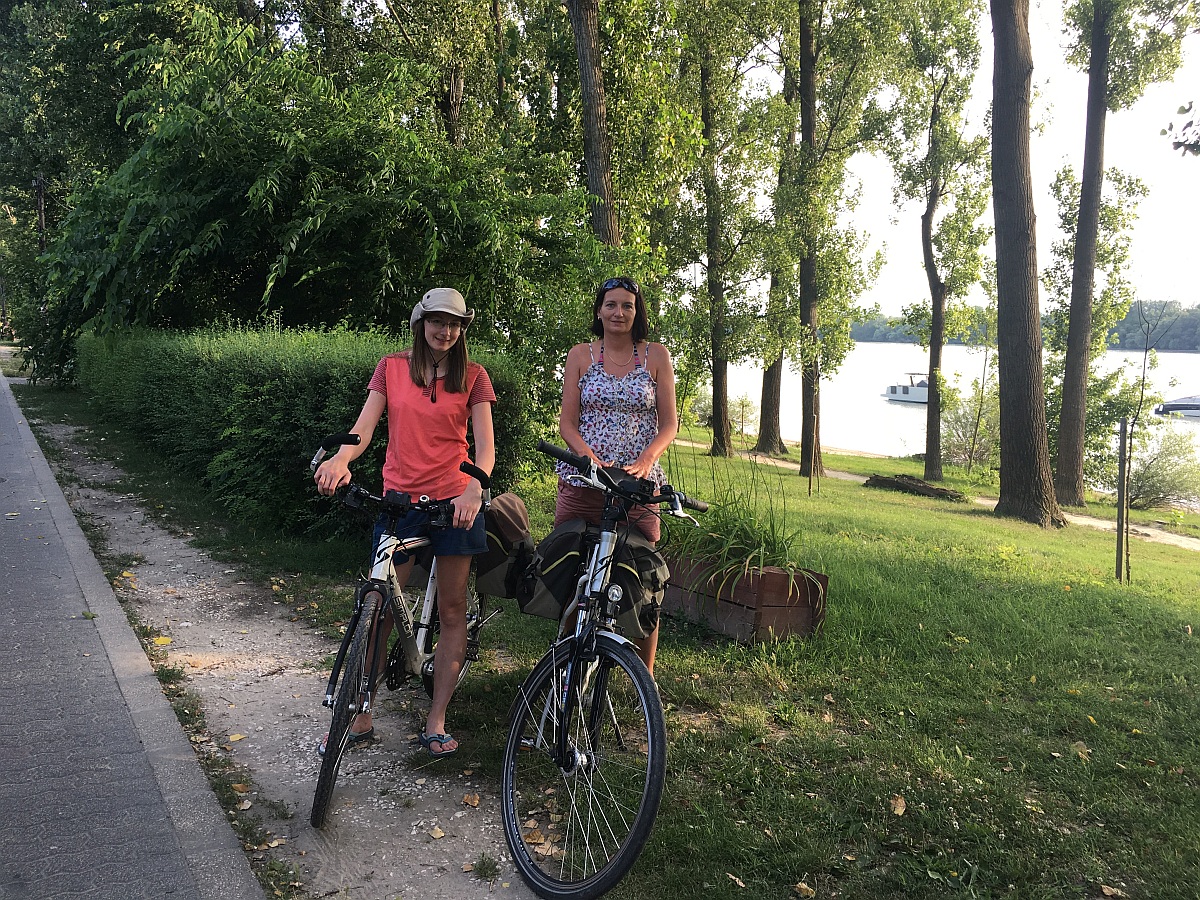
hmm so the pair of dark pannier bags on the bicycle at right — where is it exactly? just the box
[517,518,670,637]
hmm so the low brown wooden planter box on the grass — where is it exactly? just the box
[662,558,829,641]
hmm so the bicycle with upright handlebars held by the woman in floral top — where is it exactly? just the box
[500,442,708,900]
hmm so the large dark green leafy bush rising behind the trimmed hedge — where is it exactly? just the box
[28,5,610,393]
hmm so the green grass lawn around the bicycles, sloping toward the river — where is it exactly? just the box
[11,388,1200,900]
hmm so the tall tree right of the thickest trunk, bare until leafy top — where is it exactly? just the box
[1055,0,1195,506]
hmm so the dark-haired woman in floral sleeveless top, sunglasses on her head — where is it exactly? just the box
[554,278,679,674]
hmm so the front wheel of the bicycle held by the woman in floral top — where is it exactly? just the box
[500,632,666,900]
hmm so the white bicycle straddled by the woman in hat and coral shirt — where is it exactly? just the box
[308,434,499,828]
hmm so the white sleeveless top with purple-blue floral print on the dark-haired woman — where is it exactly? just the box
[554,344,667,487]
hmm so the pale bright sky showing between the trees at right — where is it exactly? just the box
[850,0,1200,316]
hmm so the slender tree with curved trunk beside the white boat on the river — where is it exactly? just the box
[886,0,990,481]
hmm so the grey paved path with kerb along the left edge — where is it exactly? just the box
[0,378,263,900]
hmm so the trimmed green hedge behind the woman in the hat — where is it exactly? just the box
[78,329,538,530]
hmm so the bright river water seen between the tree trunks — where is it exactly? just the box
[730,343,1200,456]
